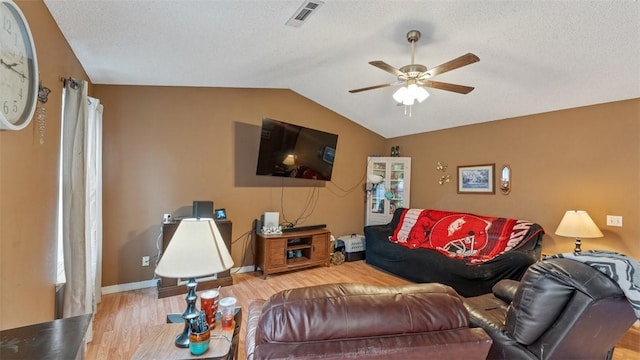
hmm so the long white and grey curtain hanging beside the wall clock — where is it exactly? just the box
[60,79,102,340]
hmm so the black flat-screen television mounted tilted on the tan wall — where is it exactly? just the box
[256,118,338,181]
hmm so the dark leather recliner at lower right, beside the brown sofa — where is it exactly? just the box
[465,259,636,359]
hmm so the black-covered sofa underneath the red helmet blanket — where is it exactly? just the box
[364,208,544,297]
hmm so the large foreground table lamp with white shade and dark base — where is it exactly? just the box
[155,218,233,347]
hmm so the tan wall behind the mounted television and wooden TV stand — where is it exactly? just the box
[94,85,384,286]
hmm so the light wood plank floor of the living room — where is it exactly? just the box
[85,261,640,360]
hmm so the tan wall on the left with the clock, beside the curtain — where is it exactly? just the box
[0,1,88,329]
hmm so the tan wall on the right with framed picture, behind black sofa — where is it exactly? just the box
[388,99,640,259]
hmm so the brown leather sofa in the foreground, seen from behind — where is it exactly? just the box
[245,284,491,360]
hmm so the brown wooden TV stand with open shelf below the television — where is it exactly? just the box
[255,229,331,279]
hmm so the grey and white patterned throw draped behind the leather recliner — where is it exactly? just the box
[545,250,640,319]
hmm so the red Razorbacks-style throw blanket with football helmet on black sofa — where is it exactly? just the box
[389,209,543,265]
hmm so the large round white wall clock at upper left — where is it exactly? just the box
[0,0,38,130]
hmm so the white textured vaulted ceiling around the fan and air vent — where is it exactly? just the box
[45,0,640,138]
